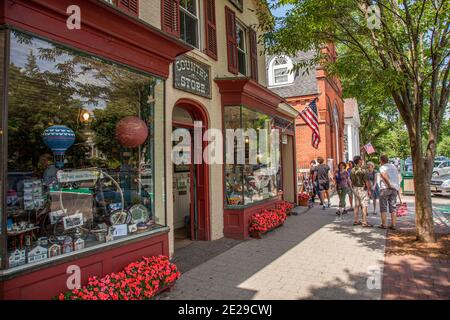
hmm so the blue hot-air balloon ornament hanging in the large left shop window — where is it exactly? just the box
[42,125,75,168]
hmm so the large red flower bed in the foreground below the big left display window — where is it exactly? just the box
[58,255,181,300]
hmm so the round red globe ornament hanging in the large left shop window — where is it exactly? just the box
[116,116,148,148]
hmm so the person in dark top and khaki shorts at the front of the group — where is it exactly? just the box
[350,156,373,228]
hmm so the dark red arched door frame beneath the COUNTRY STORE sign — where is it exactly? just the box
[172,98,211,241]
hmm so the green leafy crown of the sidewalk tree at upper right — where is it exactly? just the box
[263,0,450,160]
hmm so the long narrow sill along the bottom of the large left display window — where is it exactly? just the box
[0,227,169,280]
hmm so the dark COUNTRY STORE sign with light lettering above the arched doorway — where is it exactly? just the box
[173,56,211,98]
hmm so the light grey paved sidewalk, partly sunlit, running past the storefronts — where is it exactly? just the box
[160,198,385,300]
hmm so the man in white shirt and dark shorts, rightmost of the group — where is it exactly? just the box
[379,155,400,230]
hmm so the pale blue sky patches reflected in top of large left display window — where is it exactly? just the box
[10,33,108,111]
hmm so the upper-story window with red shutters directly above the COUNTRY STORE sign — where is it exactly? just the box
[180,0,199,48]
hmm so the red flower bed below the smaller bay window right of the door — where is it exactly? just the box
[248,201,294,238]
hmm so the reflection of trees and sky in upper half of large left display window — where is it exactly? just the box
[8,32,153,170]
